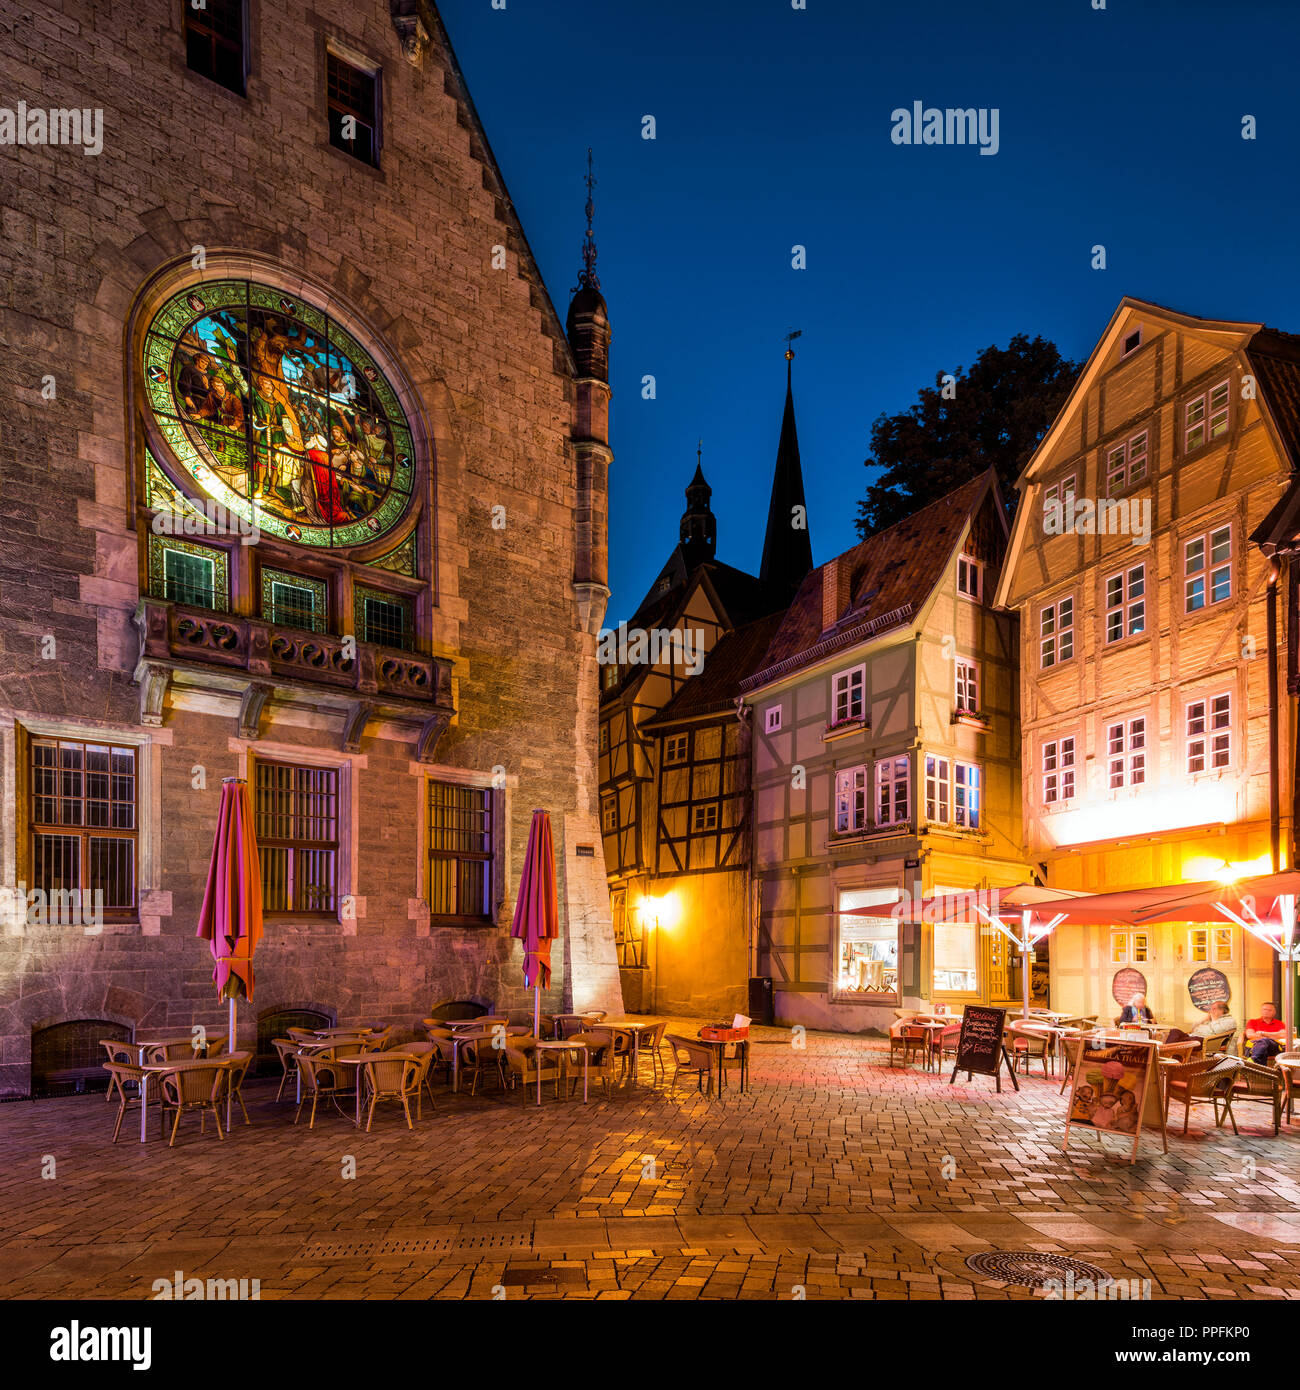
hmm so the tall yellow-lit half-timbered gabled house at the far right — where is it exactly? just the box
[997,299,1300,1026]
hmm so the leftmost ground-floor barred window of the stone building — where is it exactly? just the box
[31,738,139,922]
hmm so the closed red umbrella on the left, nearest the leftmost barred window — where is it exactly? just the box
[196,777,261,1127]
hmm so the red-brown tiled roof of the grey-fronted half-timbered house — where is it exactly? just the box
[747,473,991,685]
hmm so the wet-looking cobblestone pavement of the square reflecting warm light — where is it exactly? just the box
[0,1022,1300,1300]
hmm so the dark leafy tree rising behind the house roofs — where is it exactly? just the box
[858,334,1079,538]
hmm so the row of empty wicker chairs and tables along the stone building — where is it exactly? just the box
[99,999,749,1147]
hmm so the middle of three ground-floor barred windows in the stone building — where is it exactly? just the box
[253,759,339,915]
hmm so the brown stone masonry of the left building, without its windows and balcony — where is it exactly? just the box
[0,0,620,1093]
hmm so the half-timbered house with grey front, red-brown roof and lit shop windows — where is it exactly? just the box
[742,473,1030,1031]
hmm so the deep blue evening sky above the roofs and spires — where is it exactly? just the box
[441,0,1300,621]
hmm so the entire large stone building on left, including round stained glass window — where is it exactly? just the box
[0,0,621,1094]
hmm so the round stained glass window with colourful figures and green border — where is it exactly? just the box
[145,279,414,548]
